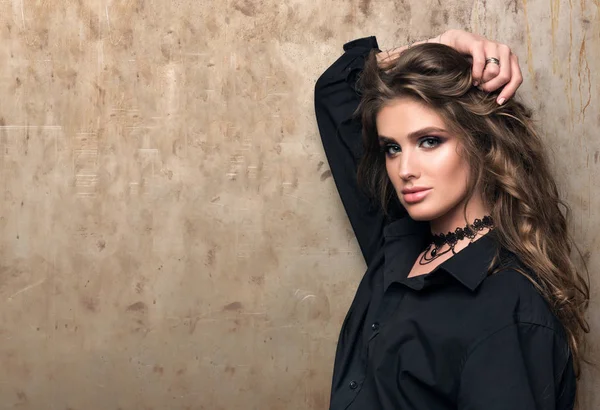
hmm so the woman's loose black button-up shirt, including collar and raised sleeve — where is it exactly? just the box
[315,37,576,410]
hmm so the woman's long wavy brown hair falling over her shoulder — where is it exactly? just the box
[355,43,589,377]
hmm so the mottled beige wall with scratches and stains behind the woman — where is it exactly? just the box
[0,0,600,410]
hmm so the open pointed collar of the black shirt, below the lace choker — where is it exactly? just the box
[383,217,499,292]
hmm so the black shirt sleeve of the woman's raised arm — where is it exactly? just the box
[314,37,404,265]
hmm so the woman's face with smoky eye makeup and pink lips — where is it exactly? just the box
[376,98,469,222]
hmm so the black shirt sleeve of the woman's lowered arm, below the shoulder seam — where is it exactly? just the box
[458,323,575,410]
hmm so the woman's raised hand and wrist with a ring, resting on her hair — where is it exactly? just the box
[377,30,523,104]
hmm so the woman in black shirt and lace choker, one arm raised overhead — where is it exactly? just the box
[315,30,589,410]
